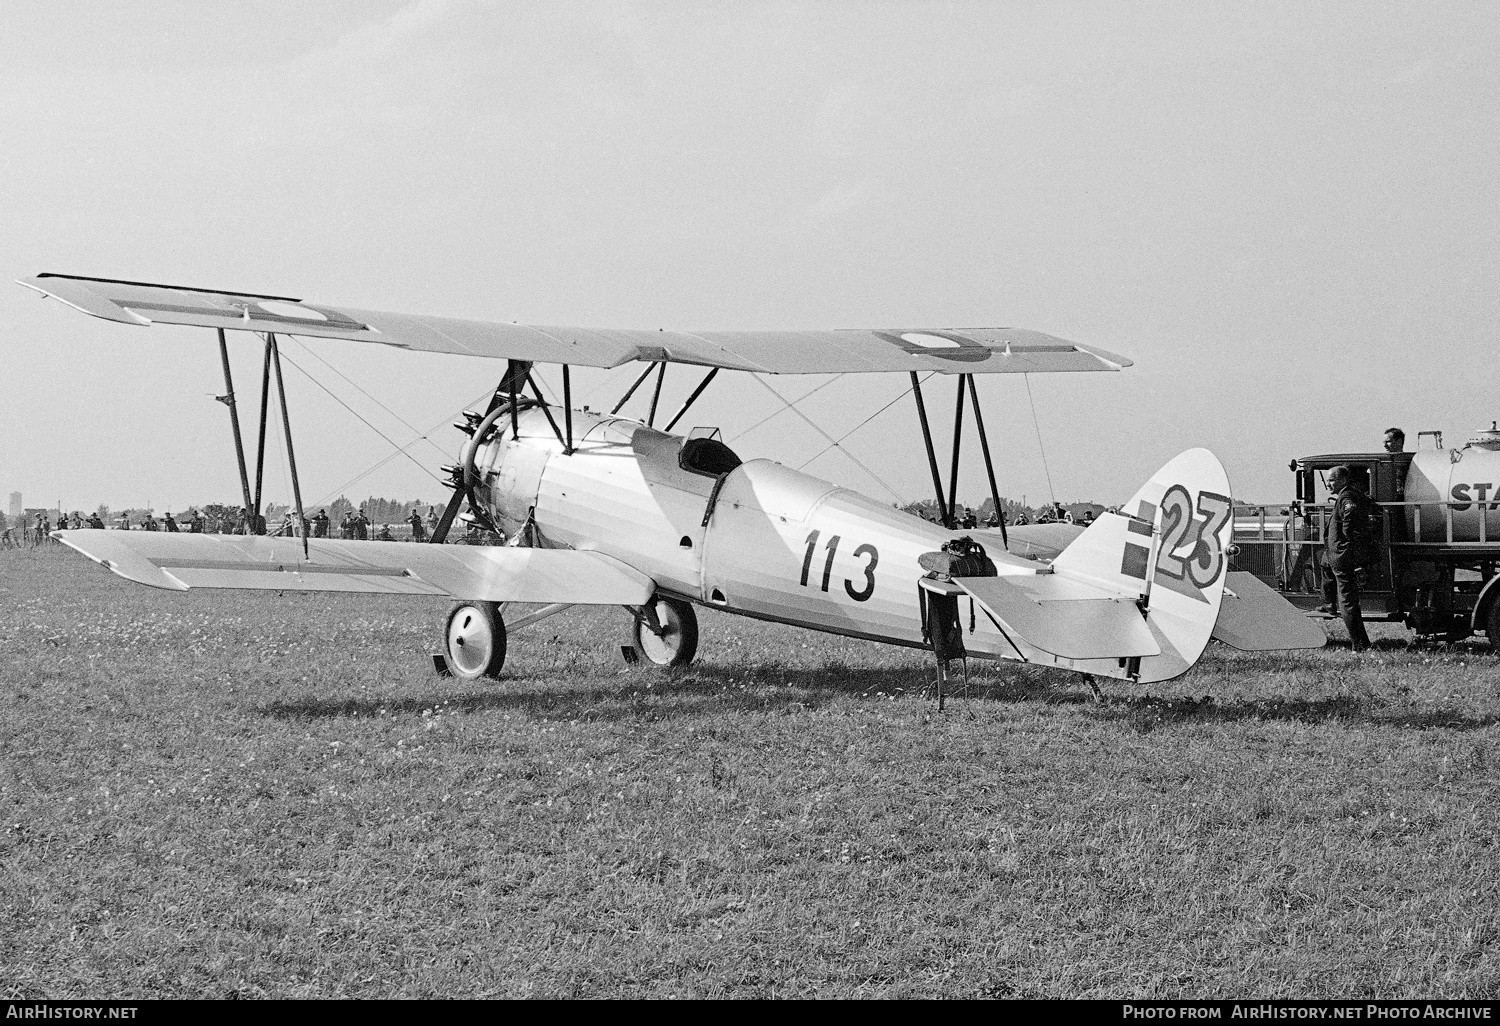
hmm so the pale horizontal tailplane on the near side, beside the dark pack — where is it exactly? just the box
[954,573,1161,659]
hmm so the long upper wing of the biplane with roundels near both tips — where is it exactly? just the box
[18,275,1131,374]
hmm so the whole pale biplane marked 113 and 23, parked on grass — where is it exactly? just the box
[20,275,1325,695]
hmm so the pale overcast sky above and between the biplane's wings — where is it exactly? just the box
[0,0,1500,510]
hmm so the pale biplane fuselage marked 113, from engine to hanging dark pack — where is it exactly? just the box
[477,410,954,645]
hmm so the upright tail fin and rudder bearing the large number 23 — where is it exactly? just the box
[1052,449,1233,683]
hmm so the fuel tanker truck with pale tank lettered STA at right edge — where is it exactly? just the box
[1230,423,1500,648]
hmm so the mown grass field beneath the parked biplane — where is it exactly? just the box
[0,549,1500,998]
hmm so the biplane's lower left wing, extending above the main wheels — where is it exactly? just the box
[53,531,656,606]
